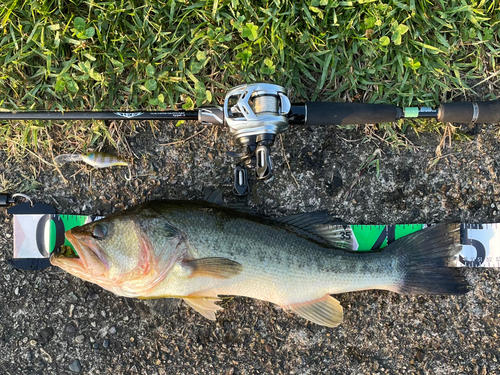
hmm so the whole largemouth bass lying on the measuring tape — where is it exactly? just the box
[51,201,468,327]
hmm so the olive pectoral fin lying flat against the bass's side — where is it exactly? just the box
[182,258,243,279]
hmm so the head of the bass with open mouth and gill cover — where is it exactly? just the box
[50,215,179,297]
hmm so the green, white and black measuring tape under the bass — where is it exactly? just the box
[7,203,500,269]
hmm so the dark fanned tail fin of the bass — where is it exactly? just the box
[387,223,470,295]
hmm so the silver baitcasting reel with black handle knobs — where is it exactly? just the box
[224,83,291,195]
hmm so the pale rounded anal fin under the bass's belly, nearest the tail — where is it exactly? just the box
[288,295,344,327]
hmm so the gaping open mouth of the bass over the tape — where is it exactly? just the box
[50,230,109,279]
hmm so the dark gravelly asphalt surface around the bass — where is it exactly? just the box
[0,123,500,374]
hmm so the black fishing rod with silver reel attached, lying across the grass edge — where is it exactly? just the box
[0,83,500,195]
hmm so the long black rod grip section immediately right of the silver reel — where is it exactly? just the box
[306,102,402,126]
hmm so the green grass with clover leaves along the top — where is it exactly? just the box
[0,0,500,154]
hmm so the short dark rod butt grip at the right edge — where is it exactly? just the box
[438,100,500,124]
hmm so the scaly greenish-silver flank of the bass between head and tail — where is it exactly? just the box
[155,212,398,305]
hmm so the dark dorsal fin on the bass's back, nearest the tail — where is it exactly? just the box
[274,211,354,250]
